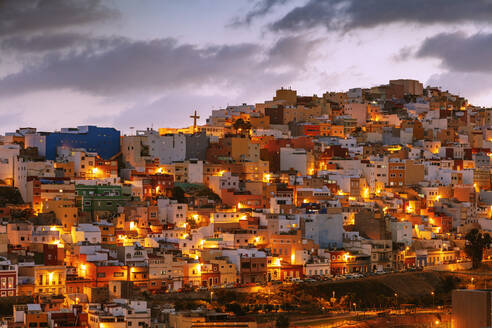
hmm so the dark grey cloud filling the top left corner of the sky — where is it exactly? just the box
[0,0,119,37]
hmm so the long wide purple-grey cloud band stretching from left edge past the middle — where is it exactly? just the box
[0,38,320,96]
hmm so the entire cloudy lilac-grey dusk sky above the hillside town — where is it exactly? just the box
[0,0,492,133]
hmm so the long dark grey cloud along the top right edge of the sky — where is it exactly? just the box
[271,0,492,31]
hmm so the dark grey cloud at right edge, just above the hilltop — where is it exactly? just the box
[416,32,492,73]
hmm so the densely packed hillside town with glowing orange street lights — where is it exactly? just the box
[0,80,492,328]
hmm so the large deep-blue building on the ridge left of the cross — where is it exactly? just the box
[26,125,120,160]
